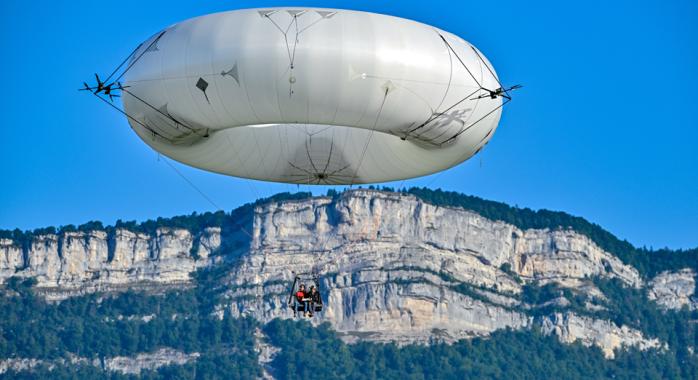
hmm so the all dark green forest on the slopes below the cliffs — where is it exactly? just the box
[0,255,698,380]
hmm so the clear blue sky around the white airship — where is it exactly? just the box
[0,0,698,248]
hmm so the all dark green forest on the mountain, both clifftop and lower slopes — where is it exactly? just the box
[0,188,698,380]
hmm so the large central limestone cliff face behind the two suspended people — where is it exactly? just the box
[223,191,642,343]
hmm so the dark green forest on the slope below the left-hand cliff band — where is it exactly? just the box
[0,268,260,379]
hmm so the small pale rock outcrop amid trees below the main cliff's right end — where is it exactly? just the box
[538,313,662,359]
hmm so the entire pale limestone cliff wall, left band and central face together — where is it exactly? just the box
[0,190,664,356]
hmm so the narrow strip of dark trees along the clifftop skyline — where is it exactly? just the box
[0,186,698,275]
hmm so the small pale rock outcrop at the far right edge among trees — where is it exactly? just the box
[647,269,698,310]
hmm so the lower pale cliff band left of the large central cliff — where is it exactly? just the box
[0,227,221,299]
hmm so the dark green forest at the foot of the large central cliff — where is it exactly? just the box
[264,320,698,380]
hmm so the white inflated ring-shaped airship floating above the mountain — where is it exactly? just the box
[98,7,515,185]
